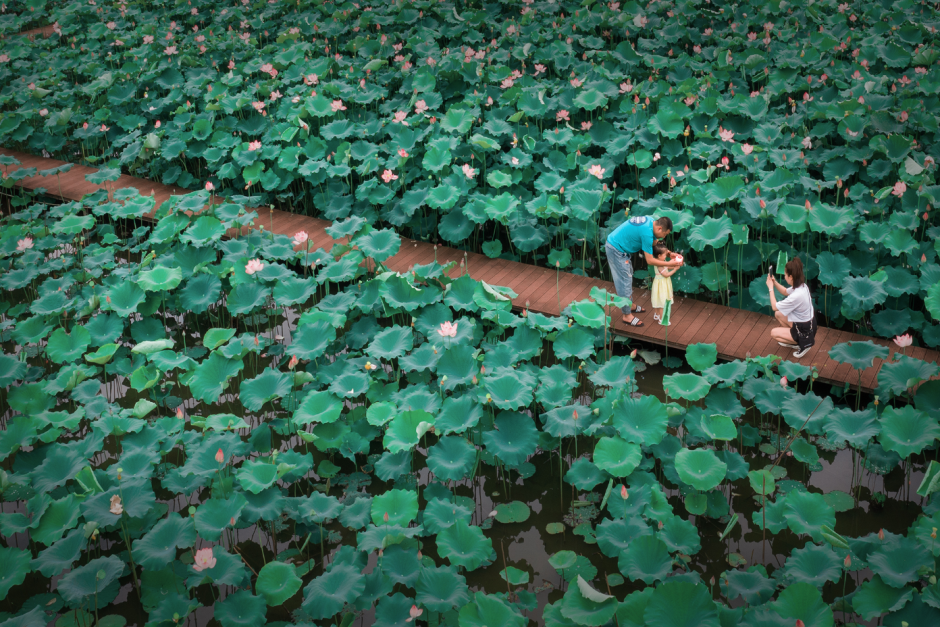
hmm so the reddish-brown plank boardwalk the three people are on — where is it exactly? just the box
[0,149,940,390]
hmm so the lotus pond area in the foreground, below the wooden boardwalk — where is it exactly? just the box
[0,189,940,627]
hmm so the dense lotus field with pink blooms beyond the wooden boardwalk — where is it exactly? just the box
[0,0,940,347]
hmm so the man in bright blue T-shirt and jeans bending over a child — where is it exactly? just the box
[605,216,682,327]
